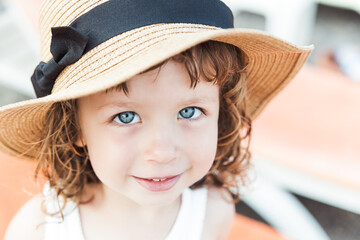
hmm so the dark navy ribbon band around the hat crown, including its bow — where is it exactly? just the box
[31,0,234,97]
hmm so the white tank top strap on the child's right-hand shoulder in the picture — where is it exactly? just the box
[166,188,207,240]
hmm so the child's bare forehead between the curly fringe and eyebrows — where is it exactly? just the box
[83,61,219,108]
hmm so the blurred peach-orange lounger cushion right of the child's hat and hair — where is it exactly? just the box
[251,65,360,192]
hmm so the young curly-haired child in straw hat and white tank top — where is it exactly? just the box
[0,0,312,240]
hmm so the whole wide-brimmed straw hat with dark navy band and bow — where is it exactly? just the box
[0,0,313,161]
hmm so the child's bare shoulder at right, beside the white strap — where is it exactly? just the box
[203,187,235,240]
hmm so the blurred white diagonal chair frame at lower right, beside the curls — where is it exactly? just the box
[243,156,330,240]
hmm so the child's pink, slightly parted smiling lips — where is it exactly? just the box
[133,174,181,192]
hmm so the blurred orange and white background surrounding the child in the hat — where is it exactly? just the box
[0,0,360,240]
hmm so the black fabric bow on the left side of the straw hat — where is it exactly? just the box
[31,26,88,97]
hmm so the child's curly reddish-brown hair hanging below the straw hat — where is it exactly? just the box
[35,41,251,213]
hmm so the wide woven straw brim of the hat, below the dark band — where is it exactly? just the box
[0,24,313,159]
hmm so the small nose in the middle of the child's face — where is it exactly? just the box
[143,121,178,164]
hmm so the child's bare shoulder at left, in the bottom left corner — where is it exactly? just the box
[5,195,45,240]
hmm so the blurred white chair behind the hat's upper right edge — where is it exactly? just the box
[223,0,317,45]
